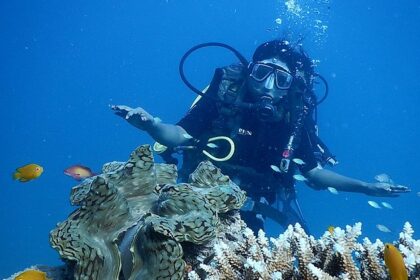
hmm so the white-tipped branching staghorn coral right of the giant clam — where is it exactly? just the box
[188,221,420,280]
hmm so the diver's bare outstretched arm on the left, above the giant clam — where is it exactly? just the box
[111,105,188,147]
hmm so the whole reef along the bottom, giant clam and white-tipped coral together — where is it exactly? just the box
[5,145,420,280]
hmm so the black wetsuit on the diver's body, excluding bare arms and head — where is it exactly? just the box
[177,87,317,231]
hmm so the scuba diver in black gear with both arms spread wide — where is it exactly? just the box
[111,40,410,232]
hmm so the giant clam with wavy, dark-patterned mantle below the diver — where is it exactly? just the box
[50,145,246,280]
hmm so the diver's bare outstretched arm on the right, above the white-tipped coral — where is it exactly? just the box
[305,168,410,196]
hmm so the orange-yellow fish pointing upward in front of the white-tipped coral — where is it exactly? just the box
[384,243,408,280]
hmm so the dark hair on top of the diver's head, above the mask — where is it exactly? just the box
[252,40,314,85]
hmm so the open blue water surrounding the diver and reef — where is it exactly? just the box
[0,0,420,277]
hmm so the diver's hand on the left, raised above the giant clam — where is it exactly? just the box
[111,105,155,131]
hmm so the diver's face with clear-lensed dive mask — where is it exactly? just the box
[248,58,293,103]
